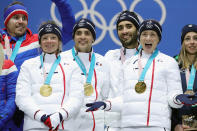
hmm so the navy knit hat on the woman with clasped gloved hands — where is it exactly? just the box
[38,23,62,42]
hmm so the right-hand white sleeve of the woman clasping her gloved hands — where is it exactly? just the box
[62,69,84,120]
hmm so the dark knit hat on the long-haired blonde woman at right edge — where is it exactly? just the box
[181,24,197,44]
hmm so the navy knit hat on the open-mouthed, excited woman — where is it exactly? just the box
[139,19,162,40]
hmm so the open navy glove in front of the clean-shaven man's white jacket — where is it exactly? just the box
[86,101,106,112]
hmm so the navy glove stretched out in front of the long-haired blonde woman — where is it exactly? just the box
[176,94,195,105]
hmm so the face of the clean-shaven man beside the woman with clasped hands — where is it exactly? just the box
[74,28,94,53]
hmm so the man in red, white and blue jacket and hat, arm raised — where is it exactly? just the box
[0,0,75,131]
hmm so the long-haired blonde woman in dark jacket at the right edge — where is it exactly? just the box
[172,24,197,131]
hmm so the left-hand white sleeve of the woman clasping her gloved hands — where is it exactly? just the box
[15,61,45,121]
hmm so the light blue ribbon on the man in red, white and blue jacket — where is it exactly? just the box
[10,35,26,62]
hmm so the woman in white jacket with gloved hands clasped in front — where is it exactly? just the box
[16,21,83,131]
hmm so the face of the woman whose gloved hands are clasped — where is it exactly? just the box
[41,33,61,54]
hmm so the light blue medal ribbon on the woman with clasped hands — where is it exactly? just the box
[40,55,61,85]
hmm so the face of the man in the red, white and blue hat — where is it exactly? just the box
[7,14,28,37]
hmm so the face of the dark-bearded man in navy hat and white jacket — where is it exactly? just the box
[117,21,137,48]
